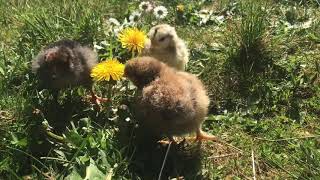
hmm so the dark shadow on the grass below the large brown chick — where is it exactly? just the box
[117,119,203,179]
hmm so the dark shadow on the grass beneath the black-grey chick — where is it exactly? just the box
[15,87,92,175]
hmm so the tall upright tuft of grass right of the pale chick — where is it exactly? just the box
[227,0,269,78]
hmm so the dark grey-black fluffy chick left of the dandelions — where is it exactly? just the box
[32,39,104,104]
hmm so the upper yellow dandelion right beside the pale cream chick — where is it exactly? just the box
[119,28,147,53]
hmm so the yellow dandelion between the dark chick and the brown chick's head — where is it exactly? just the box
[90,59,124,81]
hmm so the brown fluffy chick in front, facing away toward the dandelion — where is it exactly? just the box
[124,56,216,141]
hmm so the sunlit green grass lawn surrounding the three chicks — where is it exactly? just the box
[0,0,320,179]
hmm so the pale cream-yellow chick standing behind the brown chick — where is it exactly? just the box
[142,24,189,71]
